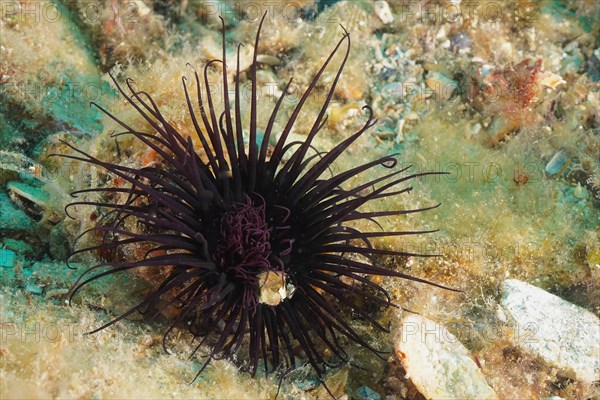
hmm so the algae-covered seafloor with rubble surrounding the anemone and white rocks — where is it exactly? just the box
[0,0,600,399]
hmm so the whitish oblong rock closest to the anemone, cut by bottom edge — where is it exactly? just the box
[395,314,498,400]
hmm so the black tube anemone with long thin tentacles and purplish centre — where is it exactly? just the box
[56,16,452,382]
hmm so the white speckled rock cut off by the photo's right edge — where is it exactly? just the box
[501,279,600,384]
